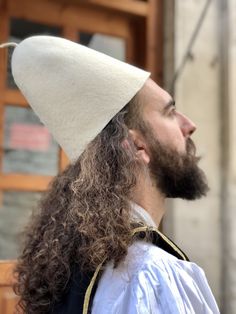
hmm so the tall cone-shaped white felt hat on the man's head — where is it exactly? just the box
[12,36,150,160]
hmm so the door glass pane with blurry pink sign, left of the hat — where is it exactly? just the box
[2,105,59,176]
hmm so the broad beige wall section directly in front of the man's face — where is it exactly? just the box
[167,0,221,303]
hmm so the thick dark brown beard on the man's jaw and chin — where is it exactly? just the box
[148,134,209,200]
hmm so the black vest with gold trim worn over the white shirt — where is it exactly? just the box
[49,227,189,314]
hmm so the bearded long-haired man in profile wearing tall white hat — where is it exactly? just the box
[1,36,219,314]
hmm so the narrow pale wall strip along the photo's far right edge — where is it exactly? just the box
[227,0,236,314]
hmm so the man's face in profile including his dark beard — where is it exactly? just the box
[136,80,208,200]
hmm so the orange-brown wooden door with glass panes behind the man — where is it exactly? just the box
[0,0,162,314]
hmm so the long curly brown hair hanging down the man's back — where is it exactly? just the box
[14,96,144,314]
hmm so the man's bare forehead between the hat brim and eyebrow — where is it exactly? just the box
[136,79,172,112]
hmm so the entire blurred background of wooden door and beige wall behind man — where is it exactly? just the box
[0,0,236,314]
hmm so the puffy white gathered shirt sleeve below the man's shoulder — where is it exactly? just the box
[111,263,219,314]
